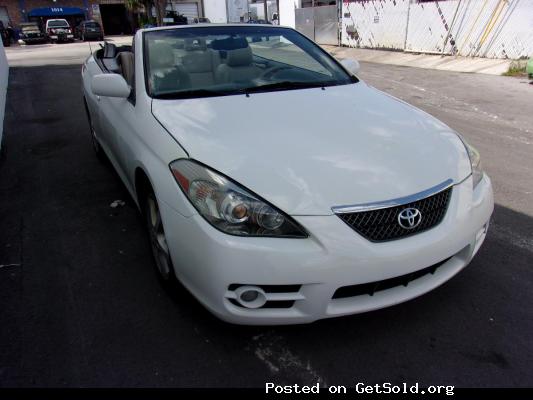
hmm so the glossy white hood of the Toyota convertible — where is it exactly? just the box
[152,82,471,215]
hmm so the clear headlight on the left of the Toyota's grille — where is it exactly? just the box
[170,159,307,238]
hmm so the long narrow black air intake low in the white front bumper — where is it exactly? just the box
[333,257,451,299]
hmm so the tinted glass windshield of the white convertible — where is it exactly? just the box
[144,26,357,99]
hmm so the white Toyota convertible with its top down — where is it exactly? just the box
[82,24,494,324]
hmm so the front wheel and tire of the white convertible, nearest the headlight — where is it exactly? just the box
[143,188,176,286]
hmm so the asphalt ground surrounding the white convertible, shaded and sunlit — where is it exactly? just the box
[0,51,533,387]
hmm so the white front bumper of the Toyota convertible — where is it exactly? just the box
[160,175,494,325]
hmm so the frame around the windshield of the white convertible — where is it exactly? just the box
[142,25,359,100]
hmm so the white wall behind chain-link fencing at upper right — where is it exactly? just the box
[341,0,533,59]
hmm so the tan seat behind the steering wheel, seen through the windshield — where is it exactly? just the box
[216,46,261,83]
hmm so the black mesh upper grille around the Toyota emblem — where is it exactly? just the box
[337,187,452,242]
